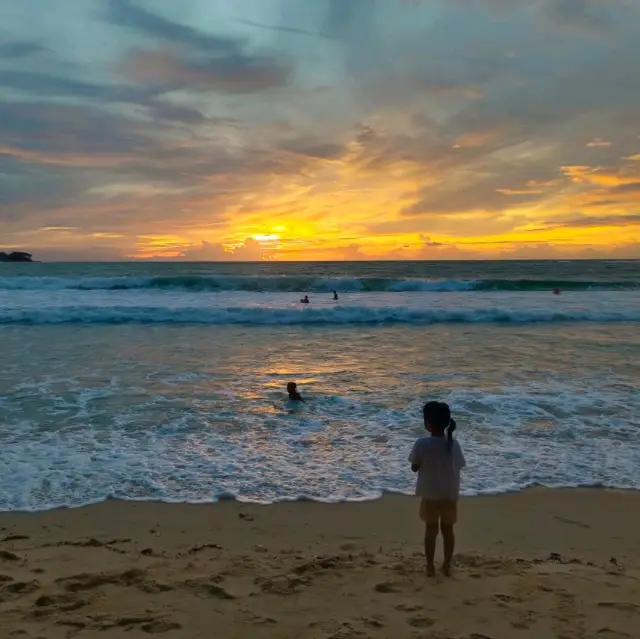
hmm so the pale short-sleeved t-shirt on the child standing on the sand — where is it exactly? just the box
[409,437,467,501]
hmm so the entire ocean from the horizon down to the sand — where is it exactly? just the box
[0,261,640,511]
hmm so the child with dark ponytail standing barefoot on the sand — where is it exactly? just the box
[409,402,466,577]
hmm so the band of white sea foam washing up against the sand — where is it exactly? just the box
[0,384,640,510]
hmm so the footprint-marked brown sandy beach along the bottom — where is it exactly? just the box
[0,489,640,639]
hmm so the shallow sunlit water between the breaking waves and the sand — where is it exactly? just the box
[0,326,640,510]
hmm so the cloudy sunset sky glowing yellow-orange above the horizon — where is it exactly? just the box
[0,0,640,260]
